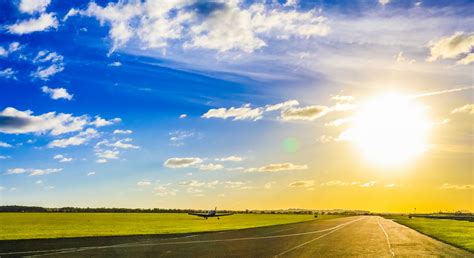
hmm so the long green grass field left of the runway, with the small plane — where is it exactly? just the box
[0,213,337,240]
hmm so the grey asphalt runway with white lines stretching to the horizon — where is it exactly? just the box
[0,216,474,257]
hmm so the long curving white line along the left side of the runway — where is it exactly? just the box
[0,218,364,256]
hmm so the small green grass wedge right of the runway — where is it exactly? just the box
[386,216,474,252]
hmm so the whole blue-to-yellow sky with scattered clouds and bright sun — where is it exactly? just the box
[0,0,474,212]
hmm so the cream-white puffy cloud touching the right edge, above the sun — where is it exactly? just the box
[427,32,474,62]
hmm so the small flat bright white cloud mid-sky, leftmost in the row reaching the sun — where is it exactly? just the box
[201,104,263,121]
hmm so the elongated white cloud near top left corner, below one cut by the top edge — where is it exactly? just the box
[7,13,58,35]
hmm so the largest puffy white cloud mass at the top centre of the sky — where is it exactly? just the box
[184,1,329,53]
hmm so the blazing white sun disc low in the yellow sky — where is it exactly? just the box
[350,94,429,166]
